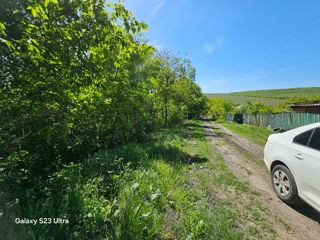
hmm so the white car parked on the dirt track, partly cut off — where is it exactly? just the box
[264,123,320,212]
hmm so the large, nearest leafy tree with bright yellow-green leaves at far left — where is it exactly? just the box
[0,0,149,170]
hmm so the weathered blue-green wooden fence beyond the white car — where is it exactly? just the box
[226,113,320,130]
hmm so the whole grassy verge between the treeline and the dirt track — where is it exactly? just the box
[0,121,275,239]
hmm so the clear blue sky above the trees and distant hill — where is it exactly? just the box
[113,0,320,93]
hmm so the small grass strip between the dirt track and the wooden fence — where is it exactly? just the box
[221,122,272,146]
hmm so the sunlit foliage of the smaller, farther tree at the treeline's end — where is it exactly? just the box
[151,51,207,126]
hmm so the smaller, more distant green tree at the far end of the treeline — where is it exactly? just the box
[154,51,204,126]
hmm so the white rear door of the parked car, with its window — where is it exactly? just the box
[293,128,320,207]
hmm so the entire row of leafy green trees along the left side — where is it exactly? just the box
[0,0,206,173]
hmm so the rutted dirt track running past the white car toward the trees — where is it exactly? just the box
[203,121,320,240]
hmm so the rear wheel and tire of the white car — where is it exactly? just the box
[271,165,302,205]
